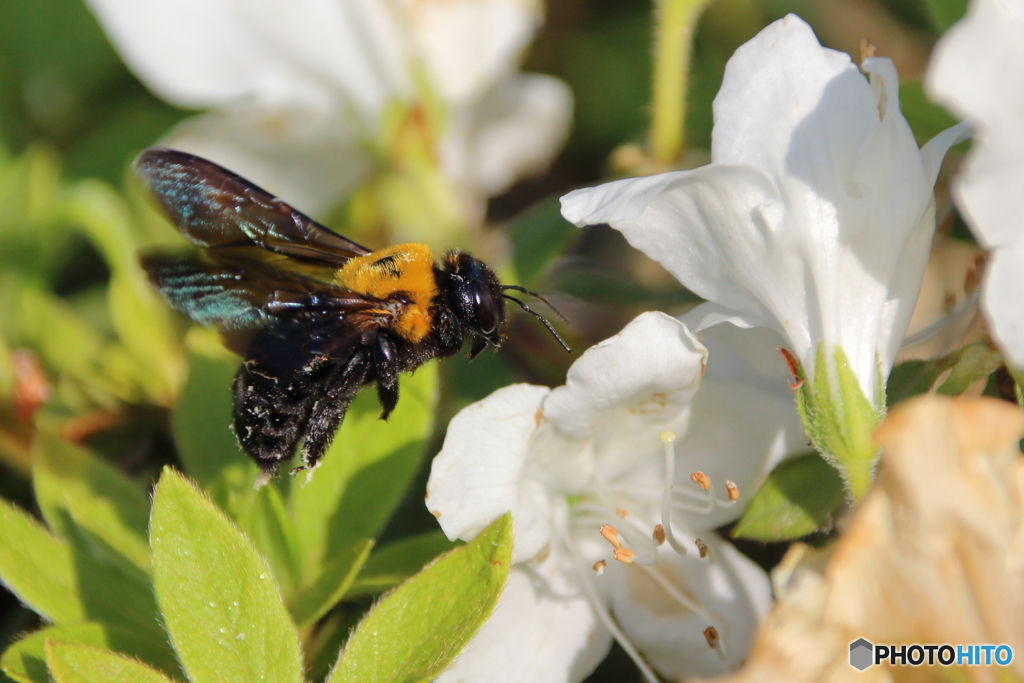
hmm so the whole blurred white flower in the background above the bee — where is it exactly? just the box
[88,0,571,219]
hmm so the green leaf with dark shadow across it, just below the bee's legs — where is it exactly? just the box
[289,364,437,586]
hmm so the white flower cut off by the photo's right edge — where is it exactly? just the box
[926,0,1024,367]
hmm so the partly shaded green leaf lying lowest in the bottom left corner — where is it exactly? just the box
[0,622,182,683]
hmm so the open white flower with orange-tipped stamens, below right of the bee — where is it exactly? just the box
[426,313,806,683]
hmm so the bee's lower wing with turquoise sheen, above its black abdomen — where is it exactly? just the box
[142,253,381,353]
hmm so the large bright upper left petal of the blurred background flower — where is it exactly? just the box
[83,0,410,119]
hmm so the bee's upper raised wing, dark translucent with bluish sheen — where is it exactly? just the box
[135,147,370,265]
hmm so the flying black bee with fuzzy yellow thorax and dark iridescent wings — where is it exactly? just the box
[135,147,569,474]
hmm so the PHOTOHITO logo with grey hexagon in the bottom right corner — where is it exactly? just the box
[850,638,1014,671]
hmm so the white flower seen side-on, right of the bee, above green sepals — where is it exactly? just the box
[562,14,959,408]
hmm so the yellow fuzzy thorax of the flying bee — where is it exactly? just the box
[337,244,437,343]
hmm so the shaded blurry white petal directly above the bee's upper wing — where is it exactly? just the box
[161,106,370,216]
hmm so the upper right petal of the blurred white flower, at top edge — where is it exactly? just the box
[407,0,543,104]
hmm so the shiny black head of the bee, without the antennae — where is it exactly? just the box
[442,249,505,356]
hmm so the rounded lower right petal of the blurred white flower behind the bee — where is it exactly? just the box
[441,74,572,202]
